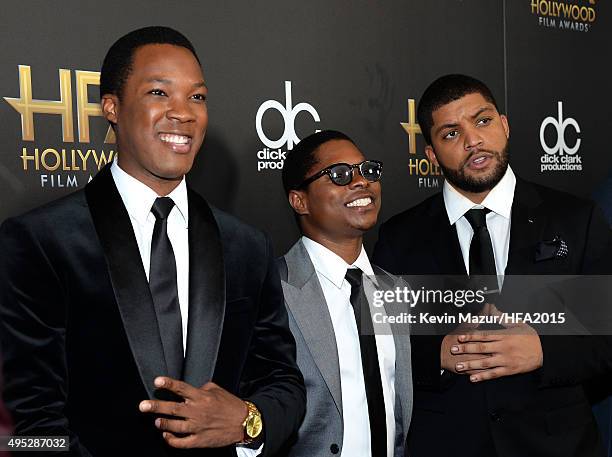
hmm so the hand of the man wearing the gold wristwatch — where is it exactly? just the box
[139,377,248,448]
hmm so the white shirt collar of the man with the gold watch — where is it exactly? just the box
[111,160,189,228]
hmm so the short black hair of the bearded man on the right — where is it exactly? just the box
[417,74,499,145]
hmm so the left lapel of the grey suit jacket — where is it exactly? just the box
[282,241,342,416]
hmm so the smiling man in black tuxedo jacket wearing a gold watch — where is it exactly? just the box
[0,27,305,456]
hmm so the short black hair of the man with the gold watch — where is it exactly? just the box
[100,26,200,98]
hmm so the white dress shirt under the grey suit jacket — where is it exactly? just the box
[302,237,395,457]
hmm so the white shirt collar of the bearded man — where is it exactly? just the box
[442,165,516,225]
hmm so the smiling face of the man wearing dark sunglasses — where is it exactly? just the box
[289,140,381,245]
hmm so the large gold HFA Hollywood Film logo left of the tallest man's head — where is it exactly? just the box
[4,65,115,187]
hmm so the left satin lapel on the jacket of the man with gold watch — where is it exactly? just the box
[85,165,168,398]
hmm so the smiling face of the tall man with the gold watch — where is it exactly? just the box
[102,44,208,195]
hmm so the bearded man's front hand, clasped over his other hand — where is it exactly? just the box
[450,323,544,382]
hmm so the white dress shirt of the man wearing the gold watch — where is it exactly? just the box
[111,160,264,457]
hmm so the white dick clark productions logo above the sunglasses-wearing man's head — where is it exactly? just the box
[255,81,321,171]
